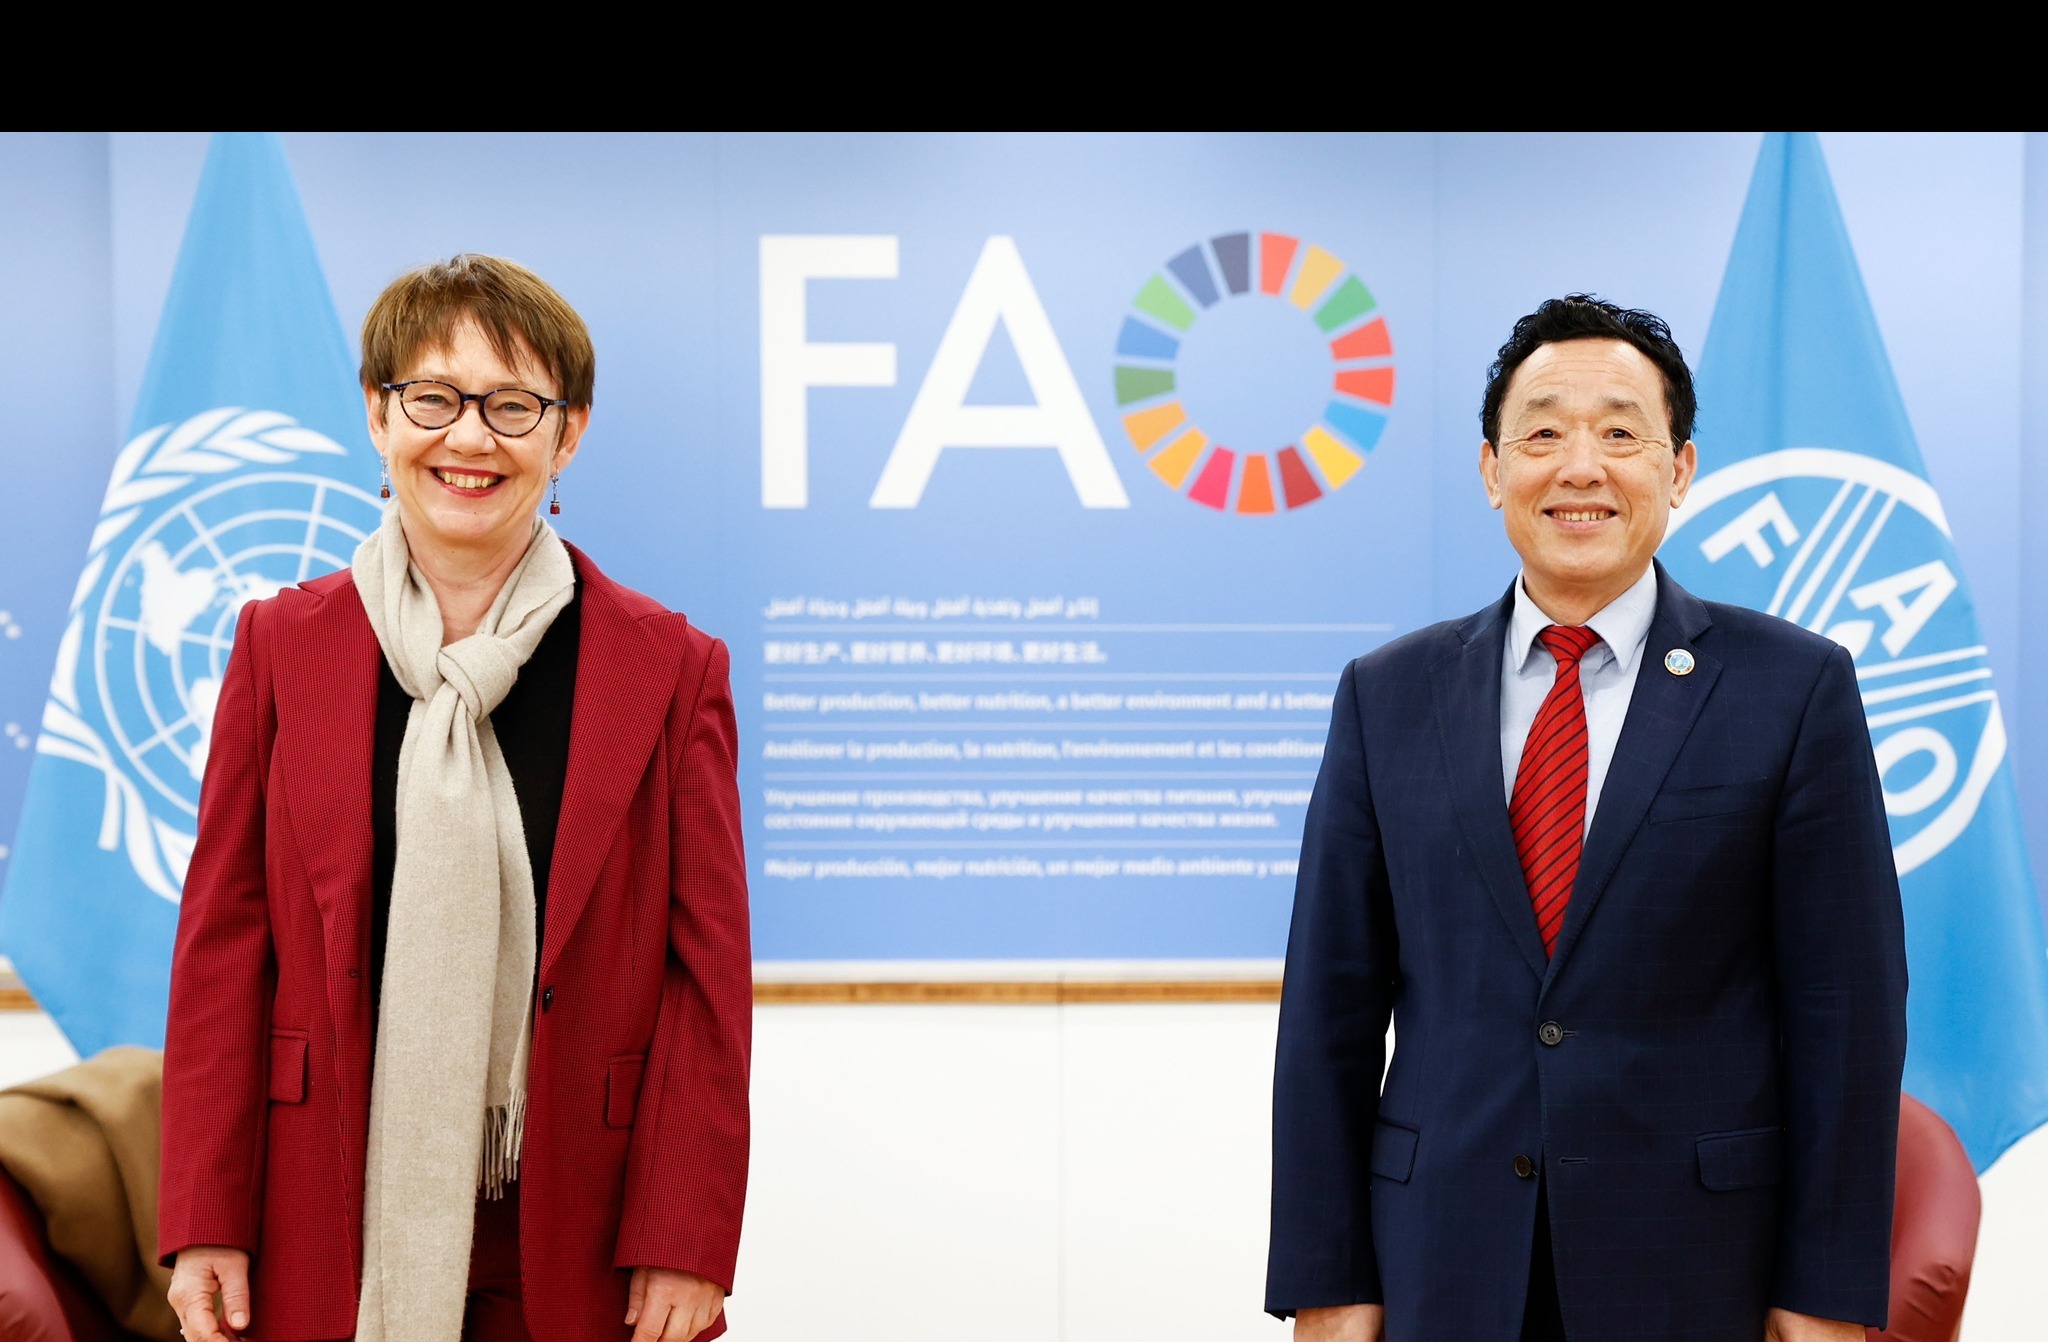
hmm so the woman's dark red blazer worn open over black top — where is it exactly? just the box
[158,547,754,1342]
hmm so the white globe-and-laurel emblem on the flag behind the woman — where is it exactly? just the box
[37,406,383,901]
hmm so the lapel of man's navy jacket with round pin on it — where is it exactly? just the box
[1546,563,1720,985]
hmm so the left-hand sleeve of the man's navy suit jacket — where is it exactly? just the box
[1266,662,1401,1317]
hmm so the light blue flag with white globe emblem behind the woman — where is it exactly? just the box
[0,135,379,1055]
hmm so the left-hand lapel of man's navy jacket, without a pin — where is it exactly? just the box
[1434,588,1544,977]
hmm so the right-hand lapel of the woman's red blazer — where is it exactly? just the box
[541,545,682,981]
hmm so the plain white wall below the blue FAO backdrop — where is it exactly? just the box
[0,1006,2048,1342]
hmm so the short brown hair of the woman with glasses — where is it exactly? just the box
[360,252,598,410]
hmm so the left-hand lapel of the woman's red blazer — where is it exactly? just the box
[272,578,383,1022]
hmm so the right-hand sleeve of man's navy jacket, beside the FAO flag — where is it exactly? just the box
[1772,647,1907,1326]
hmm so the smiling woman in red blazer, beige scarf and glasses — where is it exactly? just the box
[158,256,752,1342]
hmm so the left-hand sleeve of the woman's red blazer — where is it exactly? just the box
[158,602,276,1266]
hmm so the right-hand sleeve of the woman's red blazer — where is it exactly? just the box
[614,641,754,1291]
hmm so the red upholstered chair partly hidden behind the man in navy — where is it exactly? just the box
[1870,1094,1985,1342]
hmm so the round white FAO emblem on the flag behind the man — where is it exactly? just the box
[1663,447,2005,875]
